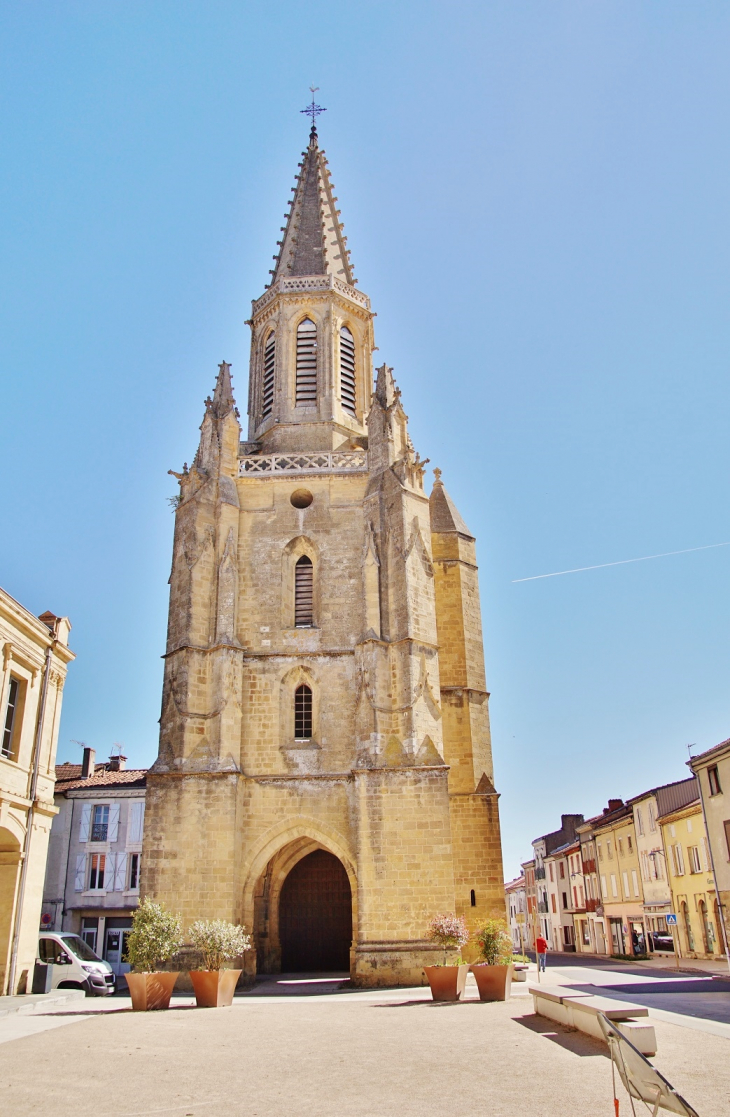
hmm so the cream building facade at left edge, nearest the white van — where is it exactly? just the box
[0,590,74,995]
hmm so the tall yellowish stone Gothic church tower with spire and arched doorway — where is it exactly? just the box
[142,126,505,985]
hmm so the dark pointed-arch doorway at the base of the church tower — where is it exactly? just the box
[279,849,353,973]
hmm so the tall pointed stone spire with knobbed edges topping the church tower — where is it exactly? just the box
[271,125,356,284]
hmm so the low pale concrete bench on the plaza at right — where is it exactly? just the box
[529,985,656,1056]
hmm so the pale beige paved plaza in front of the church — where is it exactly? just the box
[0,978,730,1117]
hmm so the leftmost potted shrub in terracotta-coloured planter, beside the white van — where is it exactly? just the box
[126,898,183,1012]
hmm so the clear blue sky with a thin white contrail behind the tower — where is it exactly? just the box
[0,0,730,875]
